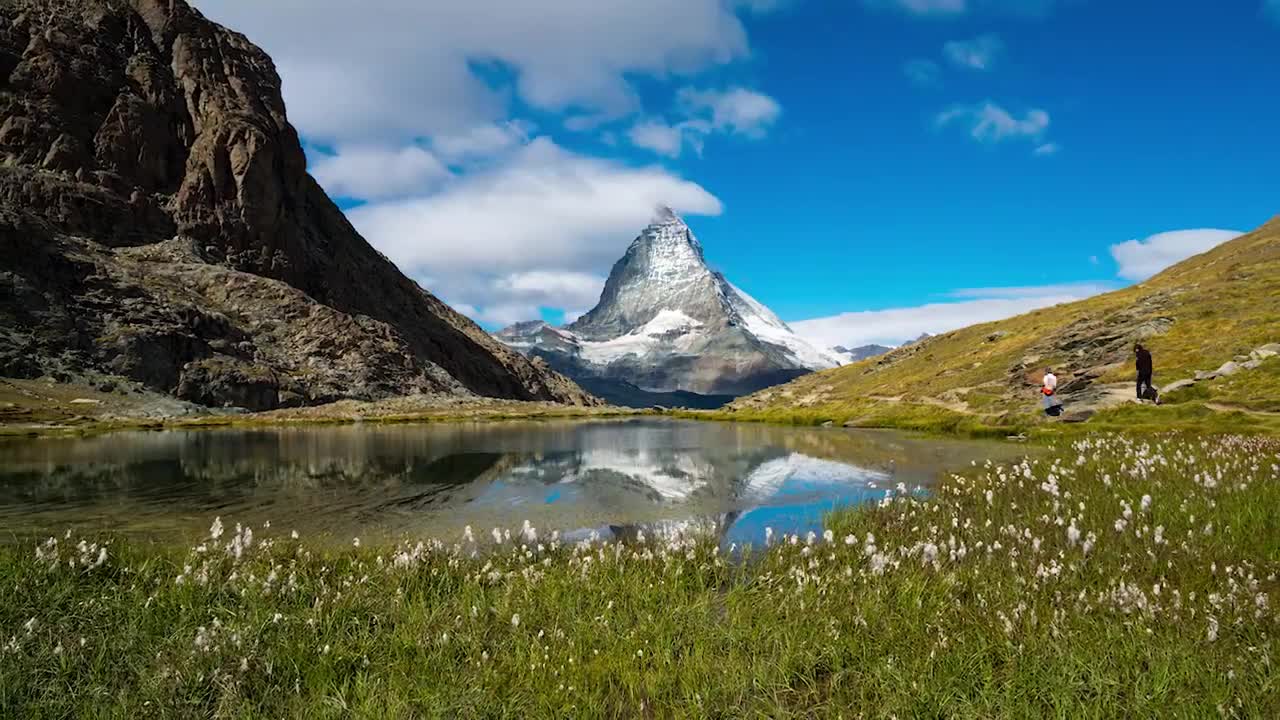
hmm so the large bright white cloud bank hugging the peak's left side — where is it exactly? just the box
[348,137,722,322]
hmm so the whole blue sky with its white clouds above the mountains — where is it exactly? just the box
[197,0,1280,345]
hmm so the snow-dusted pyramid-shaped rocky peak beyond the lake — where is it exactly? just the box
[497,206,841,406]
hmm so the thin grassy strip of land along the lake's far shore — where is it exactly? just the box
[0,371,1280,439]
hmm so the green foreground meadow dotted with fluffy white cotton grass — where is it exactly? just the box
[0,427,1280,717]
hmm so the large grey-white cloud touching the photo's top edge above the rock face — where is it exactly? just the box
[195,0,776,143]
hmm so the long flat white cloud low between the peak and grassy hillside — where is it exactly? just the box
[787,286,1097,347]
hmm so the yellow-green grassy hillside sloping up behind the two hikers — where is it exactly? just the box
[721,212,1280,432]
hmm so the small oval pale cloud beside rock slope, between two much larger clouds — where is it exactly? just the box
[310,145,451,200]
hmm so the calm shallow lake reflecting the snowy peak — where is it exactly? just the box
[0,419,1021,544]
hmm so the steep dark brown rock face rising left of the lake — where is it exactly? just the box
[0,0,596,409]
